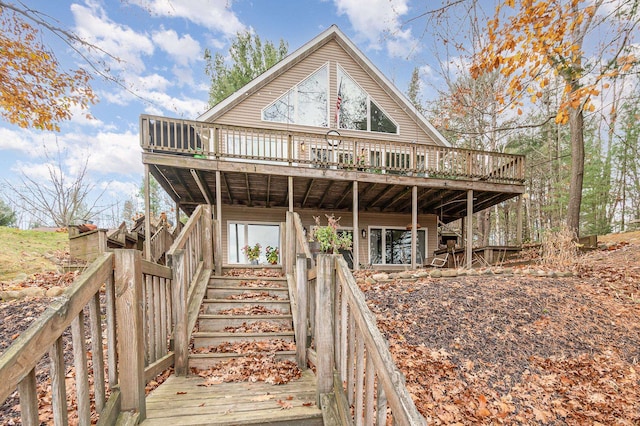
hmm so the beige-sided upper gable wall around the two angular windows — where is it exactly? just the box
[210,40,436,145]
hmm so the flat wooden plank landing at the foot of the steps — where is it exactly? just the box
[141,370,322,426]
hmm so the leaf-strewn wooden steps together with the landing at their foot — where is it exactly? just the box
[143,276,323,426]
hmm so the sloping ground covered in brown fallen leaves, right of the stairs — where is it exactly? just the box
[358,244,640,425]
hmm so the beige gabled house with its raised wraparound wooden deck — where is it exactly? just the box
[140,26,524,269]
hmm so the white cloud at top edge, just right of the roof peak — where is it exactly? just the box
[334,0,418,57]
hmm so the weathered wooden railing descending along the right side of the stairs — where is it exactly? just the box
[285,213,426,426]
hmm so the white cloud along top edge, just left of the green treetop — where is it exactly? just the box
[132,0,245,37]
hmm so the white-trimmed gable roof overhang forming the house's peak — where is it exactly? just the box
[197,25,451,147]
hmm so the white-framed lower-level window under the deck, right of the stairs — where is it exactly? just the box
[369,228,427,265]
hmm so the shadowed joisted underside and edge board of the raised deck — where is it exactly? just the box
[143,153,524,223]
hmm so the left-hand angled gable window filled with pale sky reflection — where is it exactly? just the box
[262,65,329,127]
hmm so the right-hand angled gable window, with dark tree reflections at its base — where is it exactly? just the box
[336,66,398,133]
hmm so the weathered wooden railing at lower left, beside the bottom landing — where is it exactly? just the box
[0,250,173,425]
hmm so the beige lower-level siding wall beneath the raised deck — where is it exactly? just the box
[222,206,438,268]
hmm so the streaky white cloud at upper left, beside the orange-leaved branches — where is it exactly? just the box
[71,3,154,73]
